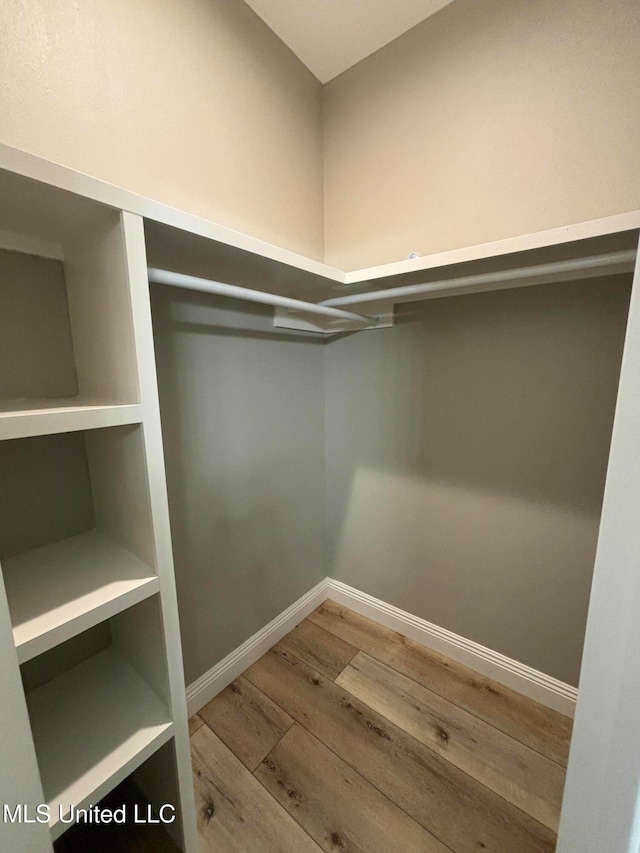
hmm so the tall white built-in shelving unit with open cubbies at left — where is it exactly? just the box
[0,156,198,853]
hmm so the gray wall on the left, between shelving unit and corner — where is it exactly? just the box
[152,287,326,683]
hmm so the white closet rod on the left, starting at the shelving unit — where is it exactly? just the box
[147,267,376,326]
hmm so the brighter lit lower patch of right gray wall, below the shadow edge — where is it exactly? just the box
[333,467,599,684]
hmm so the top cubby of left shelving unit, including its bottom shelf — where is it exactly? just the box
[0,201,142,440]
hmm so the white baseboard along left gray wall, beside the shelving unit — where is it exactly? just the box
[182,578,329,717]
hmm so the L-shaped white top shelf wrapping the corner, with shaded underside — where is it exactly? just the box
[0,144,640,301]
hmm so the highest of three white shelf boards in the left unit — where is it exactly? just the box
[0,397,142,441]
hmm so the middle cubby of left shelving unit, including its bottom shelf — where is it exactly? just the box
[0,426,160,663]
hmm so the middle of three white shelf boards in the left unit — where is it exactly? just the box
[2,530,160,663]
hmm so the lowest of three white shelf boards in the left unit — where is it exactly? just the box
[27,648,173,839]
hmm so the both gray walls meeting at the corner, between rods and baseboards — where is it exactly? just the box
[152,278,629,684]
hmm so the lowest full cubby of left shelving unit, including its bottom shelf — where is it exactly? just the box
[22,596,173,839]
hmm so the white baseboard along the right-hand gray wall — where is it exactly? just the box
[327,578,578,717]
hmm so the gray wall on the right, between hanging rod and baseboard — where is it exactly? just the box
[326,278,630,684]
